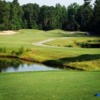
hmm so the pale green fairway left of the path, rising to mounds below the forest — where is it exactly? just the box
[0,29,86,47]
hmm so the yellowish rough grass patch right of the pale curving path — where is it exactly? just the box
[46,37,100,48]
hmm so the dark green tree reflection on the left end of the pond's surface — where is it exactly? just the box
[0,58,23,72]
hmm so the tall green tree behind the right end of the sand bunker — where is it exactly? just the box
[10,0,23,30]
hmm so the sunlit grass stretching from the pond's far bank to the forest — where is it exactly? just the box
[0,29,100,70]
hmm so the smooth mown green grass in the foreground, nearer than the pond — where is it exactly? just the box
[0,71,100,100]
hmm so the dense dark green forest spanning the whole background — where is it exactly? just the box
[0,0,100,34]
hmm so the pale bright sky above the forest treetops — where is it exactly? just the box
[6,0,95,7]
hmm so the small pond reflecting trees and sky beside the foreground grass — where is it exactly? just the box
[0,58,59,73]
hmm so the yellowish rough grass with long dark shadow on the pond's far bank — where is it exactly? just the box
[0,47,100,70]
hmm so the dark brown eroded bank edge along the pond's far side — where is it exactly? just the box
[0,55,84,71]
